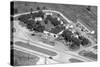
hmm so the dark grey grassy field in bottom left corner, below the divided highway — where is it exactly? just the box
[14,50,39,66]
